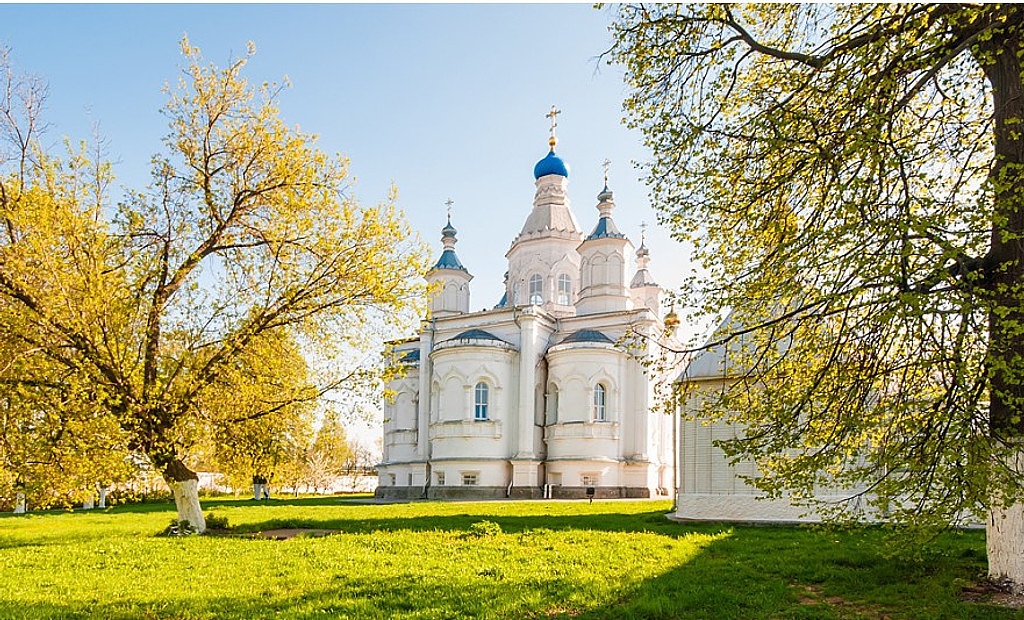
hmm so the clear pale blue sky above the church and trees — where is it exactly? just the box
[0,4,689,317]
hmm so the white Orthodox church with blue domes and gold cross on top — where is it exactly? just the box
[377,108,678,498]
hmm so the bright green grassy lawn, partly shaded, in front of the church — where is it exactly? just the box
[0,498,1024,618]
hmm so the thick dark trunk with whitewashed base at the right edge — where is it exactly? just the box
[976,5,1024,591]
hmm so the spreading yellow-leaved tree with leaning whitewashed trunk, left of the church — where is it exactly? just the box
[0,40,425,531]
